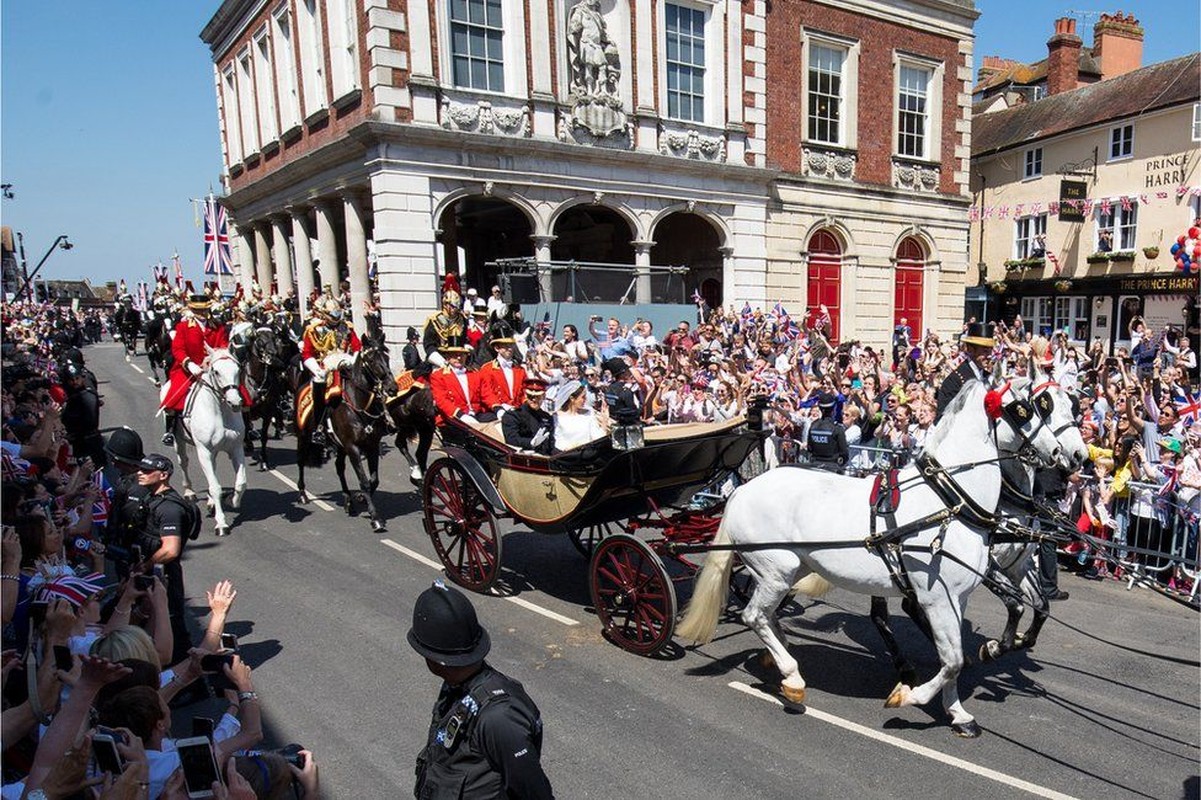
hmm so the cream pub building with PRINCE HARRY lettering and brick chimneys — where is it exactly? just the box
[967,14,1201,352]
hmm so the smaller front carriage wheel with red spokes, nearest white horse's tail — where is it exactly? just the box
[590,533,676,656]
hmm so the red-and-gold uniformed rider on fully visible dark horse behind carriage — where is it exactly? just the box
[297,299,363,444]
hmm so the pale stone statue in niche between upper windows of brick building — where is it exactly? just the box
[567,0,626,137]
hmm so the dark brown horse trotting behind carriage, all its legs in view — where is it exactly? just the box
[297,338,396,532]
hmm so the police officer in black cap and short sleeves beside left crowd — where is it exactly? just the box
[136,453,199,663]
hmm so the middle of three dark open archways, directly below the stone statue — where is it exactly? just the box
[550,204,635,303]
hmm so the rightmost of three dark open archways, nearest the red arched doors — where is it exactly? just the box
[651,211,724,309]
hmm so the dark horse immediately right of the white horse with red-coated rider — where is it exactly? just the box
[243,326,295,472]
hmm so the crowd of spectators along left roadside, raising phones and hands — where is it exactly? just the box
[0,303,318,800]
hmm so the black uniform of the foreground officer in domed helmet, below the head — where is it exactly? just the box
[413,658,555,800]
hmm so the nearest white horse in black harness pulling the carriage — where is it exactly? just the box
[676,381,1060,736]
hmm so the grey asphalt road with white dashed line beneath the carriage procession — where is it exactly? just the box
[86,344,1201,799]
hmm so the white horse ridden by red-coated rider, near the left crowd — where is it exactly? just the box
[175,347,246,536]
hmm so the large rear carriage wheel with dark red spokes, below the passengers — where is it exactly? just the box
[422,459,501,592]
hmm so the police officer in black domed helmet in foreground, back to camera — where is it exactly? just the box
[408,580,554,800]
